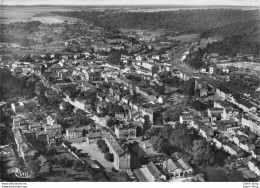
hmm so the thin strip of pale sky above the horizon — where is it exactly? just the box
[0,0,260,6]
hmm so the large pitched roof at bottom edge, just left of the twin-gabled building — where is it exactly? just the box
[134,162,162,182]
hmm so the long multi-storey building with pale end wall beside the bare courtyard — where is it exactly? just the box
[103,132,131,170]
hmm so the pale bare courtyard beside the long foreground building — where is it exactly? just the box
[71,142,113,169]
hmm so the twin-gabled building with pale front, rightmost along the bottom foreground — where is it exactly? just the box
[163,159,193,179]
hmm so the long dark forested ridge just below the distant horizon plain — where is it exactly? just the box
[53,9,260,33]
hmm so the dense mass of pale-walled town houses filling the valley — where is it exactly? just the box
[0,18,260,182]
